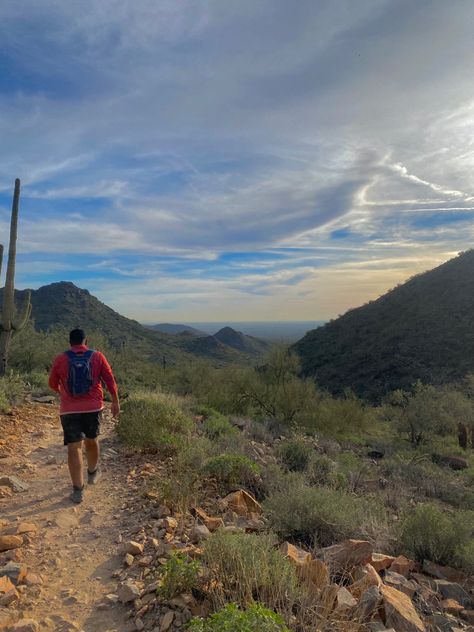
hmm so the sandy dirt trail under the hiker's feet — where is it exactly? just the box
[0,404,138,632]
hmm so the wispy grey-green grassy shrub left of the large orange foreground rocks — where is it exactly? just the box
[203,530,302,614]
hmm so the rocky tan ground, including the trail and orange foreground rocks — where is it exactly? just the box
[0,403,474,632]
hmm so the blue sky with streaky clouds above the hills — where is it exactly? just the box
[0,0,474,322]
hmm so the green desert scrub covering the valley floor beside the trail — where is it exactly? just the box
[0,325,474,632]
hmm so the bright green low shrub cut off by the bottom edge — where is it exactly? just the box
[188,603,290,632]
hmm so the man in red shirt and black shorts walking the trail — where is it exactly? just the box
[49,329,120,503]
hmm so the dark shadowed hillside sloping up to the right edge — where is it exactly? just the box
[293,250,474,400]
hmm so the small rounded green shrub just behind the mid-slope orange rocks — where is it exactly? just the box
[202,454,260,491]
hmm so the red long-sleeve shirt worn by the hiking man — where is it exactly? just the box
[49,345,117,415]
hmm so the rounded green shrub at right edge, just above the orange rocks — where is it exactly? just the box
[400,503,472,564]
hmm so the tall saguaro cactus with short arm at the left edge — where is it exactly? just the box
[0,178,31,375]
